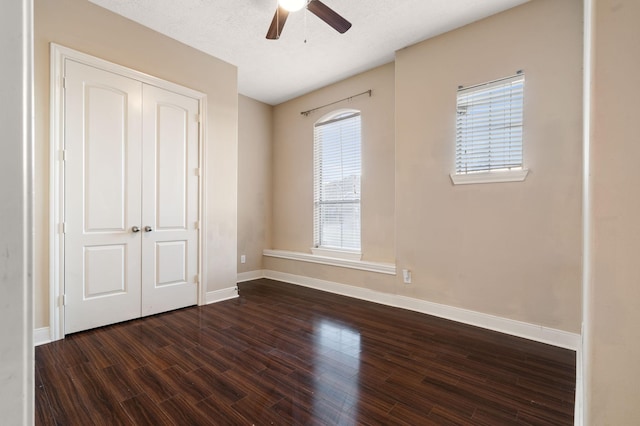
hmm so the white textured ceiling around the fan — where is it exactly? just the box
[90,0,528,105]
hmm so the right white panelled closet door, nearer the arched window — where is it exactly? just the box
[142,85,199,316]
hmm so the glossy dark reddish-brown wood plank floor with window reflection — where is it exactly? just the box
[36,280,575,425]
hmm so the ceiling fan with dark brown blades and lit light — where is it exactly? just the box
[267,0,351,40]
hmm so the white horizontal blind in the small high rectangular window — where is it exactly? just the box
[455,74,524,175]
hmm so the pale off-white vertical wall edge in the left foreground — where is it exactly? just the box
[0,0,37,425]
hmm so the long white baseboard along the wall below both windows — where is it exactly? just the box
[264,270,581,351]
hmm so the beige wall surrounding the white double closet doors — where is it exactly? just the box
[34,0,238,327]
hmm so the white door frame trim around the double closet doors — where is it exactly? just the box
[49,43,207,341]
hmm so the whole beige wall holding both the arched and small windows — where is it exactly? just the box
[264,0,582,332]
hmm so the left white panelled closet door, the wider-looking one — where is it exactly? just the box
[64,60,142,333]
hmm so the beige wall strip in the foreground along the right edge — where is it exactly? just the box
[585,0,640,425]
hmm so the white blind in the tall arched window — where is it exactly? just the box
[313,111,362,252]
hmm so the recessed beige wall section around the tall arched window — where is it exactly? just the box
[265,64,395,266]
